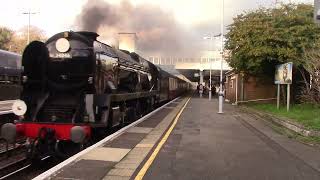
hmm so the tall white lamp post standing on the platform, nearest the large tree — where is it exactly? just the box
[218,0,224,114]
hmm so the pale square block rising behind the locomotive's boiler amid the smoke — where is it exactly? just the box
[119,33,137,52]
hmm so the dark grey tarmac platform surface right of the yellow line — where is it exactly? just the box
[144,98,320,180]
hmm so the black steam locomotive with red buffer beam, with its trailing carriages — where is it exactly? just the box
[1,31,189,156]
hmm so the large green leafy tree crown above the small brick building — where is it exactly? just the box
[225,4,320,75]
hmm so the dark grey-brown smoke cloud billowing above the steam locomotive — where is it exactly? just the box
[76,0,199,57]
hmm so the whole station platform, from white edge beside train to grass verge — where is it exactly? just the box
[35,97,320,180]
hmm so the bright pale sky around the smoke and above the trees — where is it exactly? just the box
[0,0,313,56]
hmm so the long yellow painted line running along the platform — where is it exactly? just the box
[134,97,191,180]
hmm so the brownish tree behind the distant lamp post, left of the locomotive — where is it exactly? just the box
[9,26,47,54]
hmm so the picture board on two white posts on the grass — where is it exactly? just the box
[274,62,293,84]
